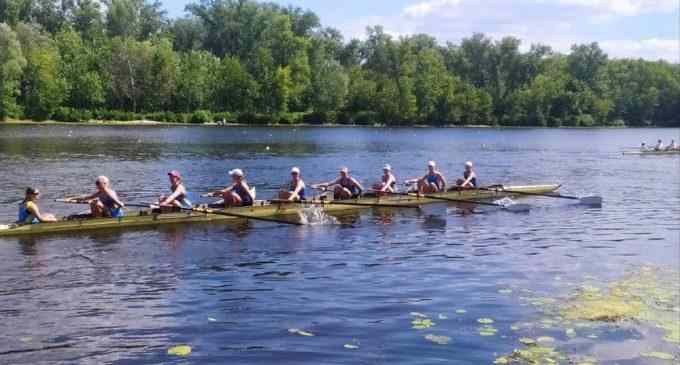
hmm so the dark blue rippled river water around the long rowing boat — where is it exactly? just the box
[0,126,680,364]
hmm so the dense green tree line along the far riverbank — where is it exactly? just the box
[0,0,680,127]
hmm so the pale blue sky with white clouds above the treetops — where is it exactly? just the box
[162,0,680,63]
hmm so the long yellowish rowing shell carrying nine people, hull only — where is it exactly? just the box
[0,184,559,237]
